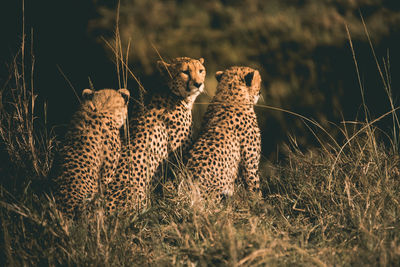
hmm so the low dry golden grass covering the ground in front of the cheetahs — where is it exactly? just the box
[0,127,400,266]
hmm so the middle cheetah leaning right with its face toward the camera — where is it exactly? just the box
[106,57,206,214]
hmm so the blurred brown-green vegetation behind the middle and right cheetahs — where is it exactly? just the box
[89,0,400,159]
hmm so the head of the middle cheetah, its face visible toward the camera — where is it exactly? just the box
[157,57,206,103]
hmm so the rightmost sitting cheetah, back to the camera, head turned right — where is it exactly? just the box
[186,66,261,202]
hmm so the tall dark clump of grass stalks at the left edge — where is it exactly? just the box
[0,4,54,184]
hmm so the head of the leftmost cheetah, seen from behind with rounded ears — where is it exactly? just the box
[82,89,130,128]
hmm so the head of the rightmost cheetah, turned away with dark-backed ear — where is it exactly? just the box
[215,66,261,104]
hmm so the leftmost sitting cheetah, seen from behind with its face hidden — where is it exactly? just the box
[53,89,130,218]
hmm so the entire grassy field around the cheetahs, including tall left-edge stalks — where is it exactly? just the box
[0,15,400,266]
